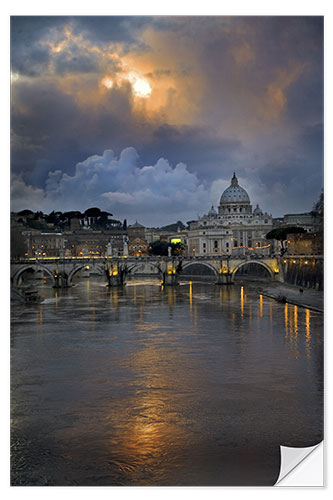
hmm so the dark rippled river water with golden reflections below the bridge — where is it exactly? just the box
[11,277,323,486]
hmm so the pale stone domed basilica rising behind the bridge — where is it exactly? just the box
[188,173,273,256]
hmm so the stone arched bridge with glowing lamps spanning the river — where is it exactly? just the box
[11,256,279,288]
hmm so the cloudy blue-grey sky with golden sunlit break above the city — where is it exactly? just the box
[11,16,323,226]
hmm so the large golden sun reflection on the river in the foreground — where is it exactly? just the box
[108,344,188,469]
